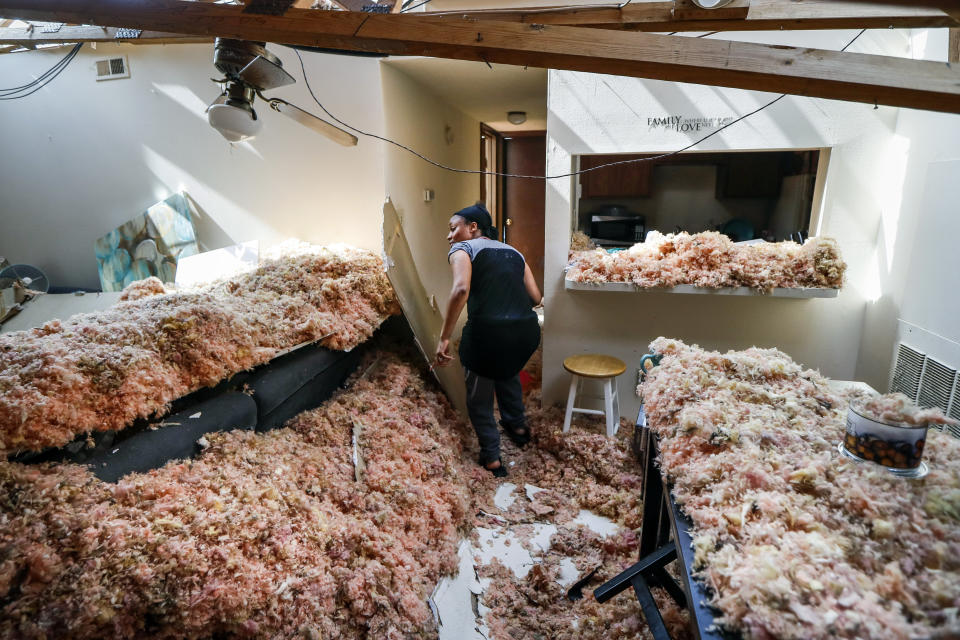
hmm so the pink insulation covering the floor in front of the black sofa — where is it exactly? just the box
[0,338,690,640]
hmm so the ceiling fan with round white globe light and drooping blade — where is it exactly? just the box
[207,38,357,147]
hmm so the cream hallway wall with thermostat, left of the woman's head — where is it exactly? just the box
[381,61,480,320]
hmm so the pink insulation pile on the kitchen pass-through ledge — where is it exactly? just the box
[567,231,846,291]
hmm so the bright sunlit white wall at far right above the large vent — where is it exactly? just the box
[857,110,960,390]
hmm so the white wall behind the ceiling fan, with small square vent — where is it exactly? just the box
[0,44,385,287]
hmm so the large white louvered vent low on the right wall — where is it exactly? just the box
[890,343,960,438]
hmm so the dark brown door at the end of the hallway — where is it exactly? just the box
[500,131,547,291]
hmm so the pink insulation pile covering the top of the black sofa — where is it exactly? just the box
[0,247,398,453]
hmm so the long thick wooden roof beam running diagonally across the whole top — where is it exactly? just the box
[0,0,960,113]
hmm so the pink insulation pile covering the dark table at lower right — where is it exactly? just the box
[638,338,960,639]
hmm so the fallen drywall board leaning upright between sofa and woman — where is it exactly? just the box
[383,199,467,416]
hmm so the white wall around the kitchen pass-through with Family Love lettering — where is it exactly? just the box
[544,31,910,416]
